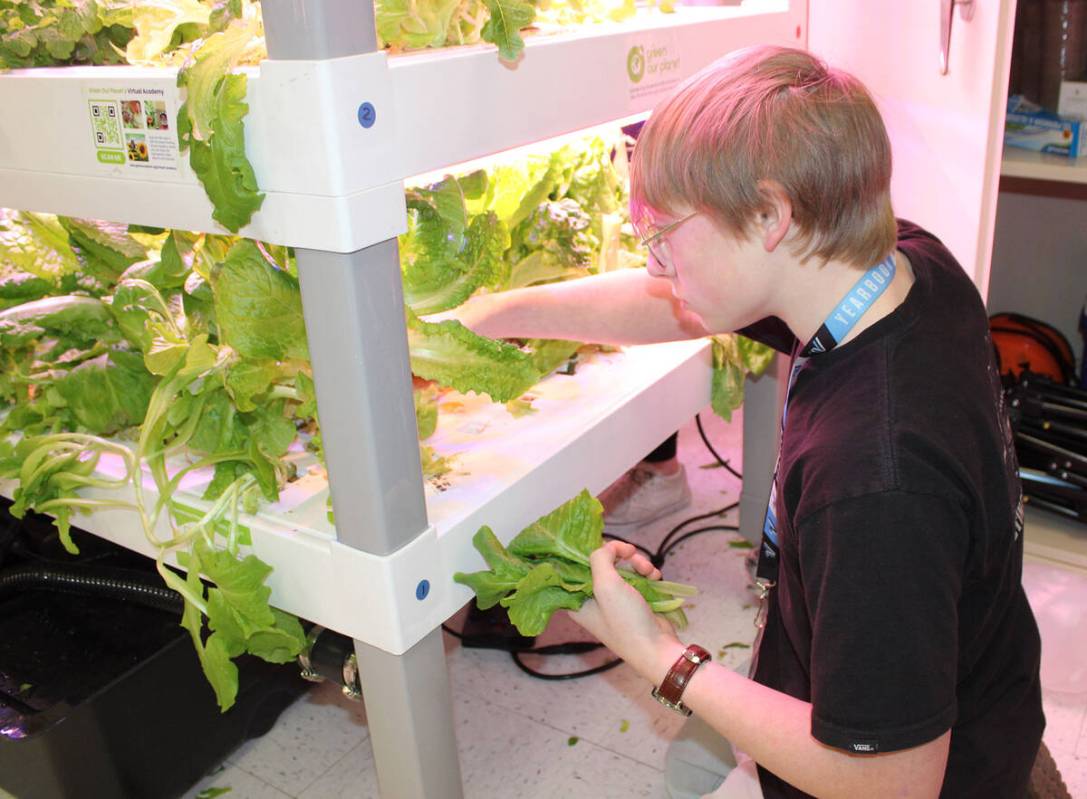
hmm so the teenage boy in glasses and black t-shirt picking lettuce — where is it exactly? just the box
[452,48,1045,799]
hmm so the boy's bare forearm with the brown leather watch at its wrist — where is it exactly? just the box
[644,645,950,799]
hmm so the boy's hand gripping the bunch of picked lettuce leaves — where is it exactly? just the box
[570,541,684,685]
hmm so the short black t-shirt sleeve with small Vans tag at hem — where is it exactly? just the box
[797,491,970,753]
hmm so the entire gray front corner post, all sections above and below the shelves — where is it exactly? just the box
[262,0,463,799]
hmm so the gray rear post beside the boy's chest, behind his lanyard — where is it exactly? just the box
[740,357,789,546]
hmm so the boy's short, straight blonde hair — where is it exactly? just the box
[630,46,897,267]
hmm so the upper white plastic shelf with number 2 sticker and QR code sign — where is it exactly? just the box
[0,0,807,252]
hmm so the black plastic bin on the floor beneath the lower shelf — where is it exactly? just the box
[0,510,309,799]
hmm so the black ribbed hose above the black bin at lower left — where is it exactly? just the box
[0,563,185,615]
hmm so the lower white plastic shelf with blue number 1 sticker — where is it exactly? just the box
[0,341,712,654]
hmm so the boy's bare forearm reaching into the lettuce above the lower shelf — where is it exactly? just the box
[455,270,707,345]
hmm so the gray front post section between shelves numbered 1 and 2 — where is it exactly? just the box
[297,239,427,547]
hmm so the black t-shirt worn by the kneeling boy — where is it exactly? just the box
[745,222,1045,799]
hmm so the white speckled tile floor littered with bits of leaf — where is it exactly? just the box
[178,417,1087,799]
